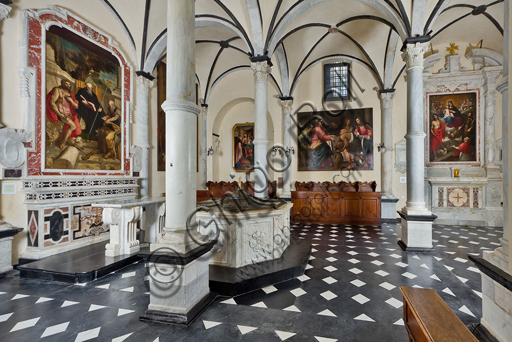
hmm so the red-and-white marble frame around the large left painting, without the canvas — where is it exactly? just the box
[19,6,133,177]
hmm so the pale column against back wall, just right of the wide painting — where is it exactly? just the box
[380,90,398,222]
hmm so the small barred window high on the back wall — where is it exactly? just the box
[324,63,350,101]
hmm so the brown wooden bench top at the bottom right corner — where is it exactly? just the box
[400,286,478,342]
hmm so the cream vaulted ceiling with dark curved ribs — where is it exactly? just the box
[98,0,504,101]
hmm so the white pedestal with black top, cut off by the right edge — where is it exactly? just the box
[469,256,512,342]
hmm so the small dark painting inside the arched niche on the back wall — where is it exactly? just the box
[233,123,254,172]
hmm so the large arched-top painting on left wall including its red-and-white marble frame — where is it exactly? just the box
[25,7,131,175]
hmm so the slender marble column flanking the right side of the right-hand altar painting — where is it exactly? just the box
[484,72,503,227]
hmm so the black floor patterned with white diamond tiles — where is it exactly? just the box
[0,224,503,342]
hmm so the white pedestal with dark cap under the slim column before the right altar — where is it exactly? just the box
[397,211,437,252]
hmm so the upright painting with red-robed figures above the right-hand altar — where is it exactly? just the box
[427,92,480,163]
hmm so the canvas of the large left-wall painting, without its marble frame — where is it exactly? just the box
[44,26,123,170]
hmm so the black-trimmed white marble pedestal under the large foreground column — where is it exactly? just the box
[140,241,217,325]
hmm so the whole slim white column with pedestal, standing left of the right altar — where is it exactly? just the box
[398,43,435,251]
